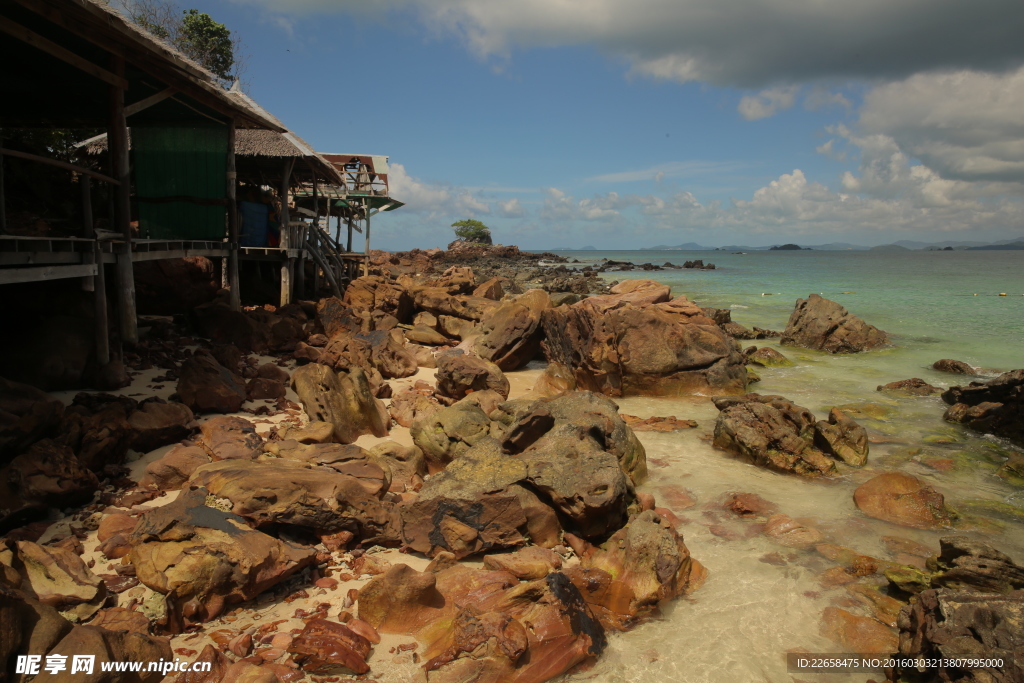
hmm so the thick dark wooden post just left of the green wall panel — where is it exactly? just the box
[106,55,138,345]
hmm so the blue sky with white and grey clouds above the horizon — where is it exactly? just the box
[188,0,1024,250]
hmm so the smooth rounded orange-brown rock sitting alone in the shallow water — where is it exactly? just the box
[853,472,951,528]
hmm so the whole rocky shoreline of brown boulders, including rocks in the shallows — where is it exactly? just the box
[0,245,1024,683]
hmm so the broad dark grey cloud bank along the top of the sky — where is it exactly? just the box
[234,0,1024,88]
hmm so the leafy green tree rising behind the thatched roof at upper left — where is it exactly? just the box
[121,0,246,81]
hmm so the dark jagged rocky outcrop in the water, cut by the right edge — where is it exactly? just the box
[942,370,1024,445]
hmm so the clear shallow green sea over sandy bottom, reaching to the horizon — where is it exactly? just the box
[525,251,1024,683]
